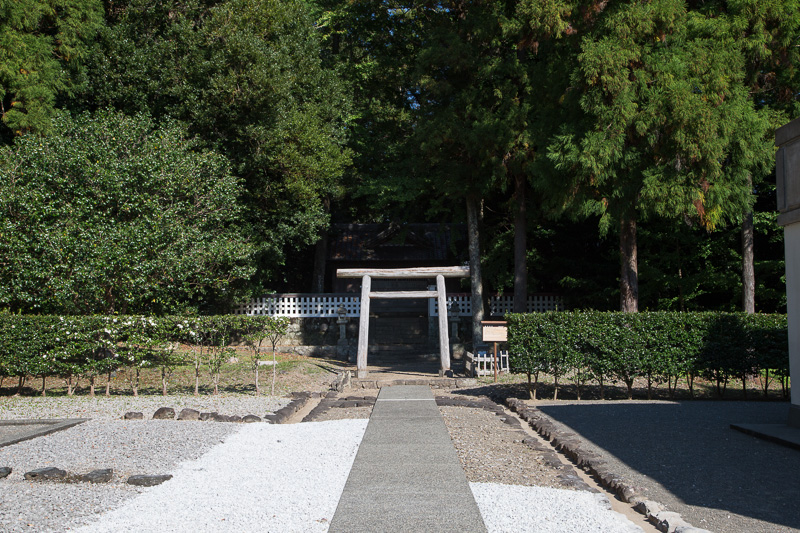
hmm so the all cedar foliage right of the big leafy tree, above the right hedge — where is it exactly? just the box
[315,0,800,311]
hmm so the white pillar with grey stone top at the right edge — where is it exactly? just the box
[775,119,800,427]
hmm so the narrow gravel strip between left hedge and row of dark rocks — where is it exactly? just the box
[0,394,291,420]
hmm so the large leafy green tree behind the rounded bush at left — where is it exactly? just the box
[72,0,350,289]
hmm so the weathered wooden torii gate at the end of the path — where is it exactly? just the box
[336,266,469,378]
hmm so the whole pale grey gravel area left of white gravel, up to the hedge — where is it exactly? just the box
[0,395,289,533]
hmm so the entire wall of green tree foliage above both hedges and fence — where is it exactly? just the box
[0,0,800,314]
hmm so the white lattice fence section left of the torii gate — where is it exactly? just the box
[235,293,361,317]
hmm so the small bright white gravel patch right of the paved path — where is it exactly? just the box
[469,483,642,533]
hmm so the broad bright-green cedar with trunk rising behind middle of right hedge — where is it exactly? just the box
[550,0,772,311]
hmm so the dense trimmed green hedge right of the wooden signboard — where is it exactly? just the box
[506,311,789,398]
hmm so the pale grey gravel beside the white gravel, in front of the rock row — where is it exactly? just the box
[0,420,245,532]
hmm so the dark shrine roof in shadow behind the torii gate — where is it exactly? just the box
[328,224,463,261]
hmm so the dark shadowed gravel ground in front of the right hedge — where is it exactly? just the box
[530,401,800,533]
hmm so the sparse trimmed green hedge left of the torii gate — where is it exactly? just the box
[0,314,288,395]
